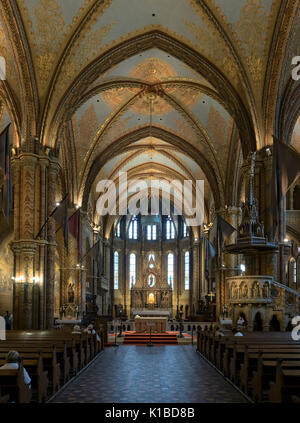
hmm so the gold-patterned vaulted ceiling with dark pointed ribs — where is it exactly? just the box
[0,0,300,224]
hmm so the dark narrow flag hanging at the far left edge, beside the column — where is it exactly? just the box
[0,124,12,221]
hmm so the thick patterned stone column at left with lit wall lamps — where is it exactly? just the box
[11,152,53,329]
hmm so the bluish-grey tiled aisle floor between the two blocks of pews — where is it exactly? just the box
[53,345,246,403]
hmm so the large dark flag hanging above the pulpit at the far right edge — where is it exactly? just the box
[271,136,300,239]
